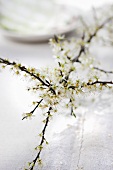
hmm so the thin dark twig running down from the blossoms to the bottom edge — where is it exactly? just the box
[29,107,52,170]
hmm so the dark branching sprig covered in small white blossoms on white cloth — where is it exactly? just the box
[0,4,113,170]
